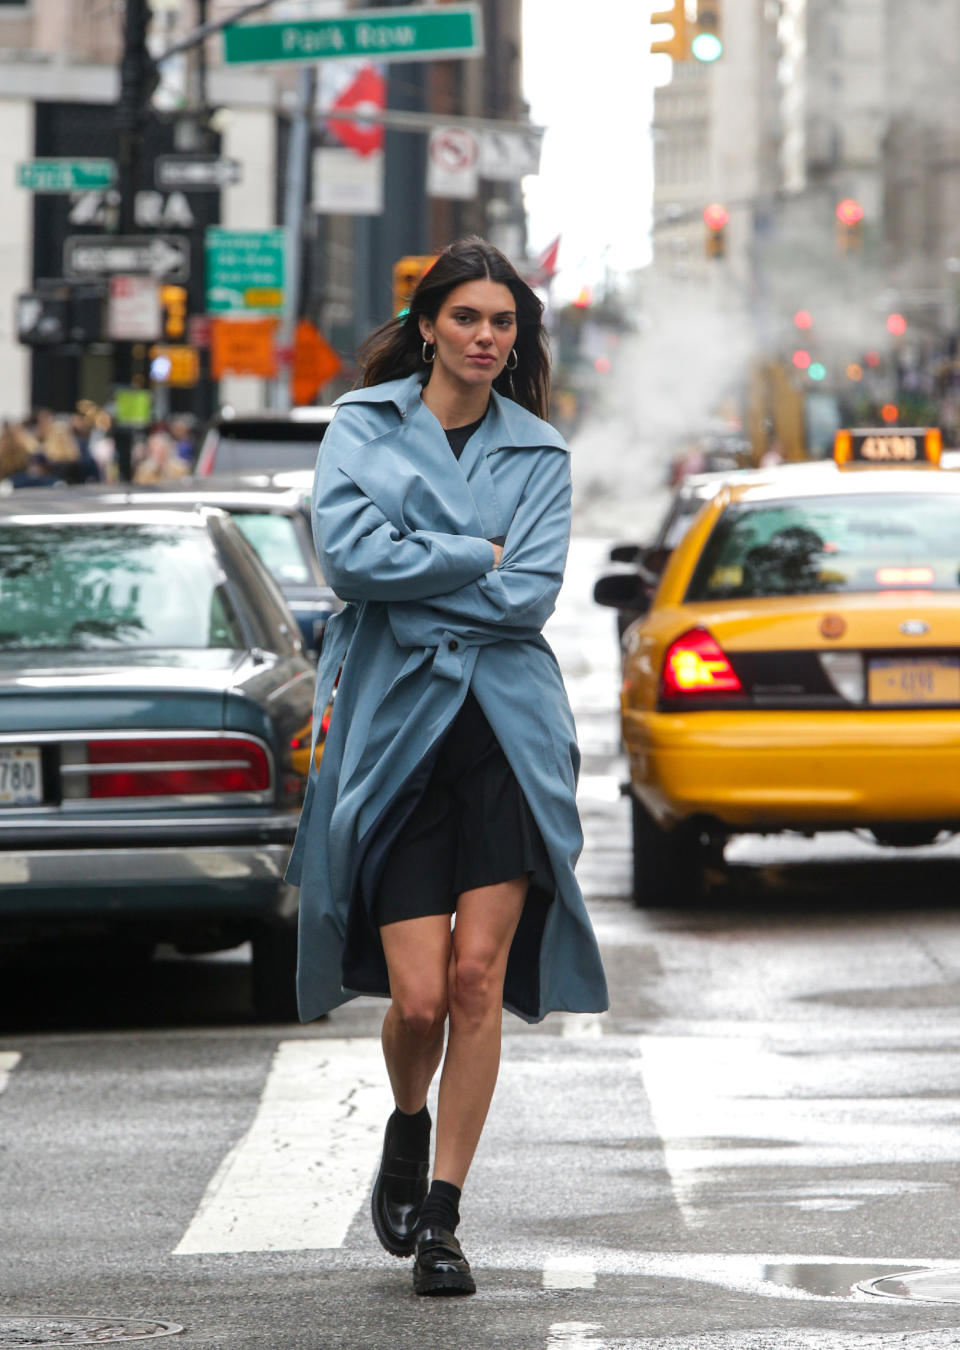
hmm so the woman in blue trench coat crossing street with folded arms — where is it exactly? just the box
[288,239,606,1295]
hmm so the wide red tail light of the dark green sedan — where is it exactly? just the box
[77,736,270,801]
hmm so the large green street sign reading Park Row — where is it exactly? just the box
[223,4,483,65]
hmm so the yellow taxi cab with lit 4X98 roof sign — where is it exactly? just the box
[594,429,960,906]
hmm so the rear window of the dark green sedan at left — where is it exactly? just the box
[0,522,246,652]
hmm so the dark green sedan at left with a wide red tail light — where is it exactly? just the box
[0,502,315,1019]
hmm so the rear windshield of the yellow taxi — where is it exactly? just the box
[686,494,960,601]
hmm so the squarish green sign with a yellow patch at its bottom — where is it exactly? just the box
[204,225,286,315]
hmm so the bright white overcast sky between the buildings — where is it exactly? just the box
[524,0,654,294]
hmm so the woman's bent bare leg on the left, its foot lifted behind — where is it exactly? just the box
[379,914,451,1115]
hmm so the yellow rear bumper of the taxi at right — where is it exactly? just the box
[622,709,960,832]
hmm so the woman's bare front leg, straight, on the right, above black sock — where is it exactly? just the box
[433,876,529,1188]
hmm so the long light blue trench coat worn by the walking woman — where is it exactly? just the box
[288,375,608,1022]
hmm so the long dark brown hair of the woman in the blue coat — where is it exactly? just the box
[359,235,550,417]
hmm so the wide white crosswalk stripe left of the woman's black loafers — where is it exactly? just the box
[176,1038,393,1256]
